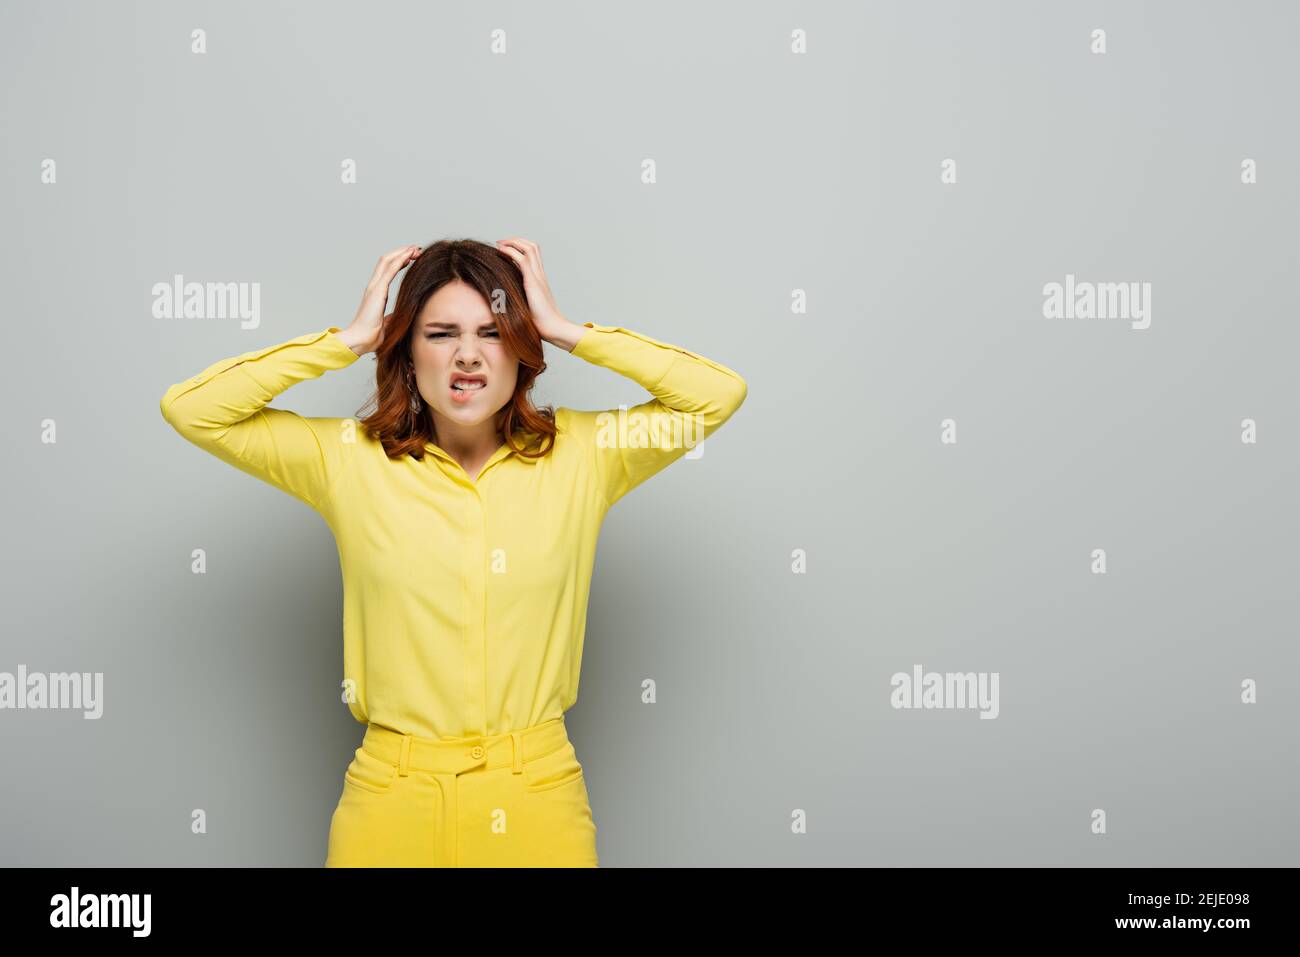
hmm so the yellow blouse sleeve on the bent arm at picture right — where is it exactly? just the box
[569,322,749,506]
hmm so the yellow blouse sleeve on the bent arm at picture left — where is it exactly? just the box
[160,326,360,511]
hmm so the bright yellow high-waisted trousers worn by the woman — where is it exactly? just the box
[325,715,598,867]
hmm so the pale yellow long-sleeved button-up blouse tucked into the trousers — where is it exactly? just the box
[161,322,748,739]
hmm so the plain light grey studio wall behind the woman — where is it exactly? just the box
[0,3,1300,866]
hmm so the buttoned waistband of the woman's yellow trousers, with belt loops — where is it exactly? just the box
[361,715,568,776]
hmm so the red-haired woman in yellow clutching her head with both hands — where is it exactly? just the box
[161,238,746,867]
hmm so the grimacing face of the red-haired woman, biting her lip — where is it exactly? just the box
[411,280,519,428]
